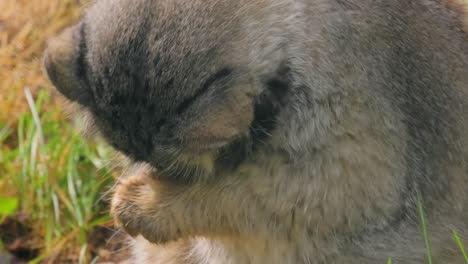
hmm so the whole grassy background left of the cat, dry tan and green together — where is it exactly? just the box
[0,0,125,263]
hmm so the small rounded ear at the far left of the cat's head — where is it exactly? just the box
[43,23,92,105]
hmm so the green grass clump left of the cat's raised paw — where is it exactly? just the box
[0,88,112,263]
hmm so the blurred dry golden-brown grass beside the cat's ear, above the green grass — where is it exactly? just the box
[0,0,84,126]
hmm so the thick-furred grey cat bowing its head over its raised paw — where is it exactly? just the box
[45,0,468,264]
